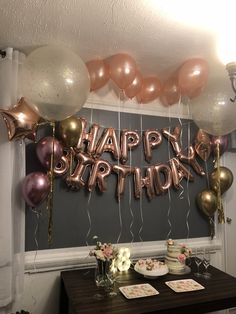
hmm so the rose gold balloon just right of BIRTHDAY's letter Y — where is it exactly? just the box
[194,129,211,161]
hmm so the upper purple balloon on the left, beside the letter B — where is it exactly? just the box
[36,136,63,169]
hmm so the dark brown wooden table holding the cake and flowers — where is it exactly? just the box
[60,266,236,314]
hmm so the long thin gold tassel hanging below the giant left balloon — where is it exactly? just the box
[47,122,55,246]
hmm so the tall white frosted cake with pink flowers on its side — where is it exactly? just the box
[165,239,191,274]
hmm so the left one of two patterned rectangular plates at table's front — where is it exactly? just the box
[119,283,159,299]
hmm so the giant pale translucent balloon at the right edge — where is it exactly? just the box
[190,78,236,136]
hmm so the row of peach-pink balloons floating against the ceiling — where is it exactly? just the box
[86,53,208,106]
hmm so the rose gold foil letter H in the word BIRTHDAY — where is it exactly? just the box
[134,167,155,200]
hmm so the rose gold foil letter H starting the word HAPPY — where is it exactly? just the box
[76,118,100,155]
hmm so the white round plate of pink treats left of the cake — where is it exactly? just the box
[134,259,169,279]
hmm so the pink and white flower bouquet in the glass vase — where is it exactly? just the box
[89,241,118,262]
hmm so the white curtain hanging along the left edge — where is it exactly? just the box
[0,48,25,314]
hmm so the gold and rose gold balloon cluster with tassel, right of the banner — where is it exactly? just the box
[195,135,233,236]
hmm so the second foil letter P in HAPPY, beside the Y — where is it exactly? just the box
[143,129,162,162]
